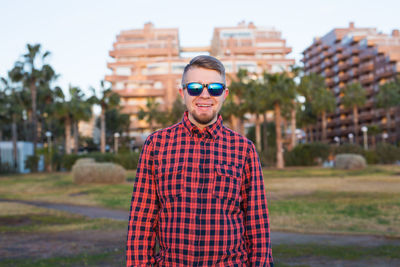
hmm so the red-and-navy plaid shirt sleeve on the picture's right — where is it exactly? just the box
[241,143,274,267]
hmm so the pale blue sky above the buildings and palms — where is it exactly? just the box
[0,0,400,98]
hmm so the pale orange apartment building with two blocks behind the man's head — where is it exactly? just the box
[105,22,294,136]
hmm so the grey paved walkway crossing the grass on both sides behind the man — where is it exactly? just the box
[0,199,400,247]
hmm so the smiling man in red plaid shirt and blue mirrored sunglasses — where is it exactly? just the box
[126,56,273,267]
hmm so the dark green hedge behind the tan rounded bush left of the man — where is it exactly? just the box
[62,152,139,170]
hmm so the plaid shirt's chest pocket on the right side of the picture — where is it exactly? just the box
[213,165,241,201]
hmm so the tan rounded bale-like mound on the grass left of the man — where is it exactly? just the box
[72,162,126,184]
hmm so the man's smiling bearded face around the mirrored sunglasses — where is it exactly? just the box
[179,68,229,129]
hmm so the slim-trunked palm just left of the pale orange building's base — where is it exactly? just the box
[88,81,120,153]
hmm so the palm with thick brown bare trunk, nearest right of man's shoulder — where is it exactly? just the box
[263,73,296,169]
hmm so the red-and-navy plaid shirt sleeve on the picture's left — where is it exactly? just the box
[126,138,159,267]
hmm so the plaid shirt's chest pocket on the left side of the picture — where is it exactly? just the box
[156,163,185,200]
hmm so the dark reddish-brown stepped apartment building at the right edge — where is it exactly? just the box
[302,23,400,142]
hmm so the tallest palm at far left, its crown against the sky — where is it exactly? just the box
[9,44,57,153]
